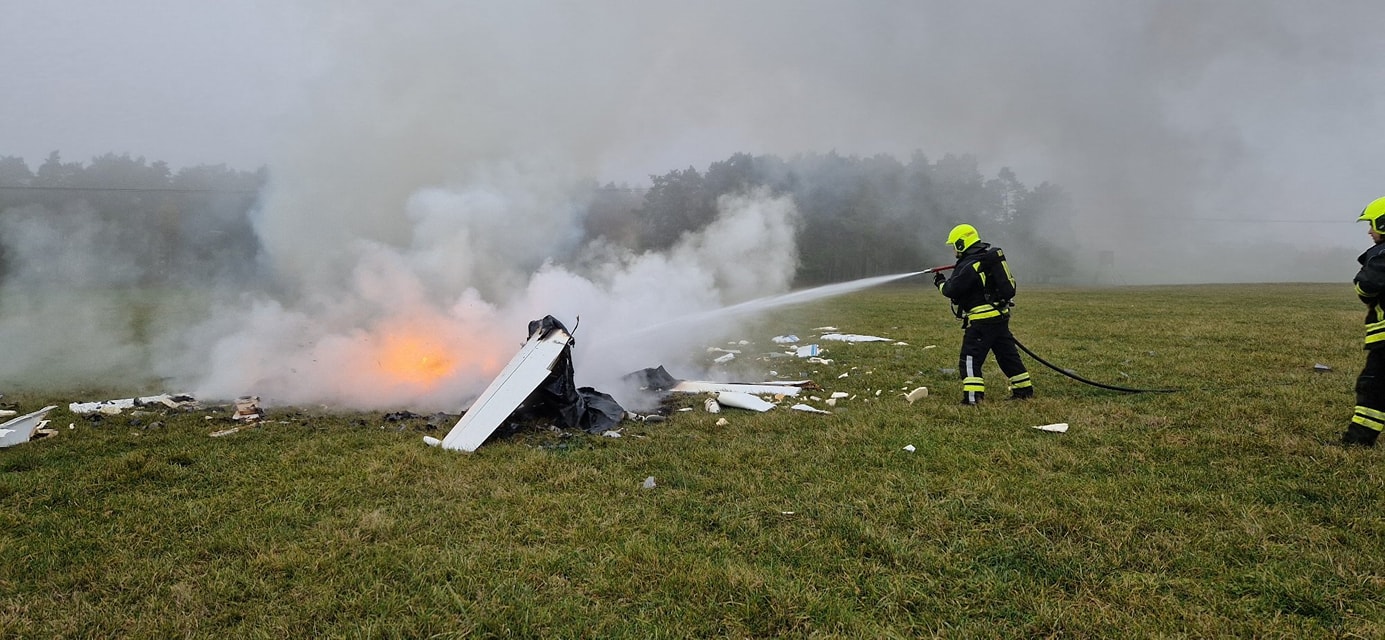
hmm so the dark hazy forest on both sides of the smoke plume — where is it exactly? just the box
[0,147,1073,285]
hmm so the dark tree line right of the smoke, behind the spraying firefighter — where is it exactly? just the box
[587,152,1075,285]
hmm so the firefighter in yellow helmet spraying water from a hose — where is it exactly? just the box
[933,224,1035,405]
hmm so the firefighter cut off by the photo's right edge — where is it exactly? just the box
[1342,198,1385,446]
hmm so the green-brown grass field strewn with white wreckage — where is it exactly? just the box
[0,284,1385,639]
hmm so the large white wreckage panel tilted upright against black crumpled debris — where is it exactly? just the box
[442,330,572,452]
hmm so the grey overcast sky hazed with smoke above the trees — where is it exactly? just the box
[0,0,1385,252]
